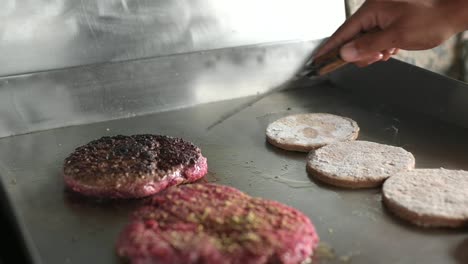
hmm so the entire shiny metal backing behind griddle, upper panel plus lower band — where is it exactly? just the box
[0,0,345,137]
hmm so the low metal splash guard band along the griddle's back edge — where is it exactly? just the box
[0,41,319,137]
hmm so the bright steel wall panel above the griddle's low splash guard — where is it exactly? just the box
[0,0,345,76]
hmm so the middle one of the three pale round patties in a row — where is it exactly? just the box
[307,141,415,188]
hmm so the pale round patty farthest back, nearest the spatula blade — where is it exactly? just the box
[266,113,359,152]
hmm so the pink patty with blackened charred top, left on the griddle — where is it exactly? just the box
[63,135,208,198]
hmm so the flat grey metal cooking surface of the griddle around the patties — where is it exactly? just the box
[0,84,468,264]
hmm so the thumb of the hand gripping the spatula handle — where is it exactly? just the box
[340,29,397,62]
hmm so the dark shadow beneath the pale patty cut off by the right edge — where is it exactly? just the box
[382,204,468,235]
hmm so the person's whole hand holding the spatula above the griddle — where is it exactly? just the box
[315,0,468,66]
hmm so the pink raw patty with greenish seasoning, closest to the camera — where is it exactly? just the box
[117,184,318,264]
